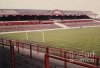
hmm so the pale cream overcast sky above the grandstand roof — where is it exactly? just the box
[0,0,100,17]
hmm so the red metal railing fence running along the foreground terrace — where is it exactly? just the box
[0,38,100,68]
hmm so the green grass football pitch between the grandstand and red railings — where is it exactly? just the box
[0,27,100,56]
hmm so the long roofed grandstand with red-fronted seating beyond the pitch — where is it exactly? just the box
[0,9,100,32]
